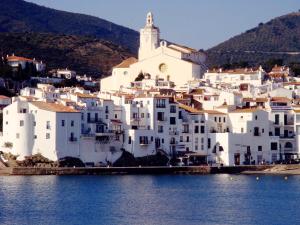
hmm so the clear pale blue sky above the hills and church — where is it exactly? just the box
[27,0,300,49]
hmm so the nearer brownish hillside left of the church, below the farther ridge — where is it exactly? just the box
[0,33,132,77]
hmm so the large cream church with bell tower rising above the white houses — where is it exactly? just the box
[100,12,206,91]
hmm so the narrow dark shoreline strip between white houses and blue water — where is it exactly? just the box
[0,165,300,176]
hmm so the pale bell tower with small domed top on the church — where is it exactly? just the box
[139,12,160,60]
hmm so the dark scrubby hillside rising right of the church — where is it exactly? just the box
[207,12,300,66]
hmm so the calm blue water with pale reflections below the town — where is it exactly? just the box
[0,175,300,225]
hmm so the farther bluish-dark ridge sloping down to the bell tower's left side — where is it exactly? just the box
[0,0,139,52]
